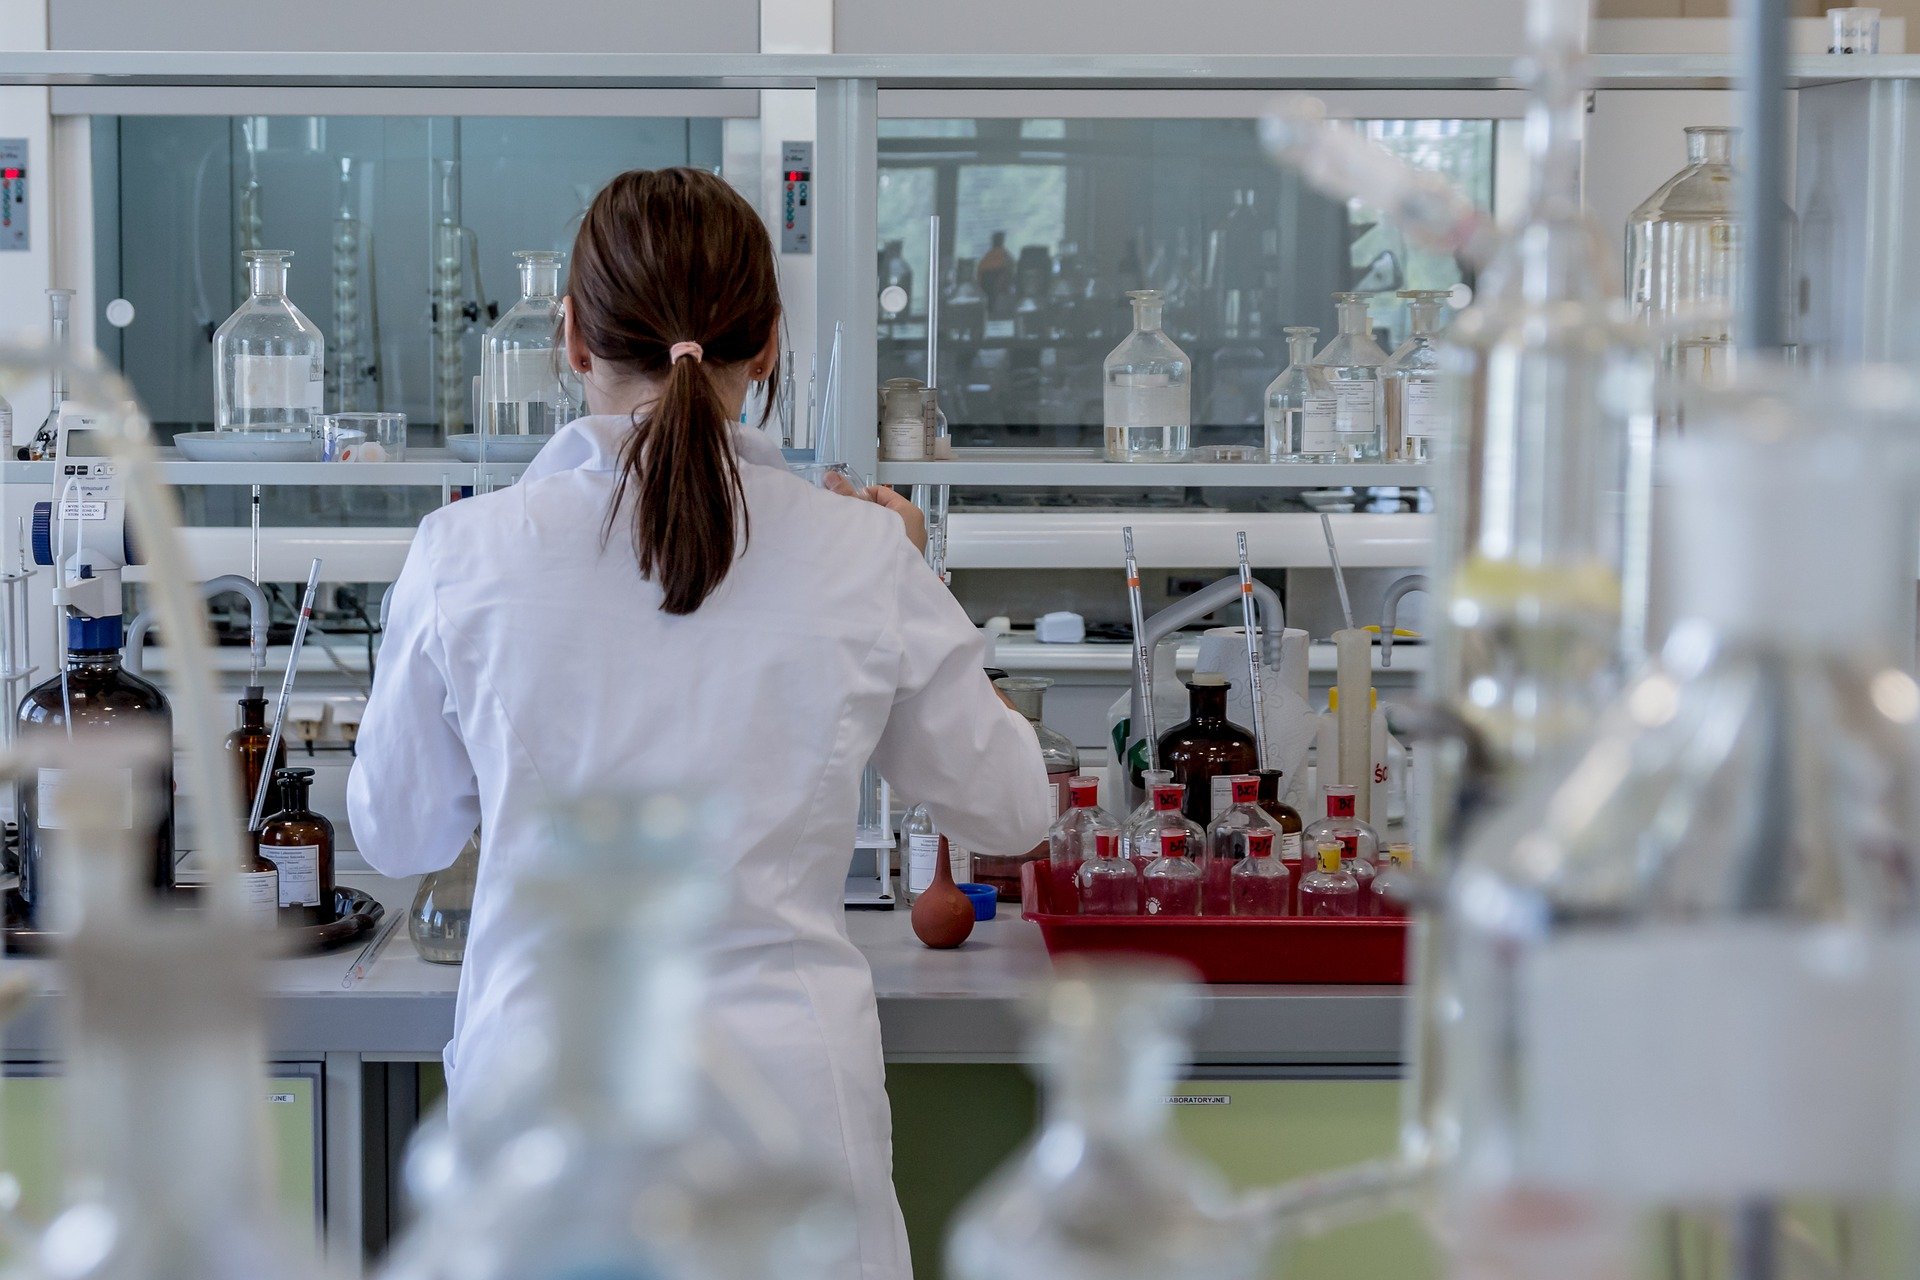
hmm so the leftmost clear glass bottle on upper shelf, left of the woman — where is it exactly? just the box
[213,249,326,430]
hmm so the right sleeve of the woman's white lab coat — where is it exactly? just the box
[874,539,1054,854]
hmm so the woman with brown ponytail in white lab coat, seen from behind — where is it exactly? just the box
[348,169,1052,1280]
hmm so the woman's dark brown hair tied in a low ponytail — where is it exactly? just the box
[566,169,780,614]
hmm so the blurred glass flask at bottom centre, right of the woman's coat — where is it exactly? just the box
[947,960,1265,1280]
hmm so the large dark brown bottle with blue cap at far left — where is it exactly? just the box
[13,616,173,923]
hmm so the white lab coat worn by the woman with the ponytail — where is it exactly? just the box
[348,416,1052,1280]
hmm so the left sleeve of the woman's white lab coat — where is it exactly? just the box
[348,520,480,875]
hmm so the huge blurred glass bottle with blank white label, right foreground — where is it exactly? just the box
[1438,370,1920,1278]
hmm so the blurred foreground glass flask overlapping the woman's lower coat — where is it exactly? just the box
[384,794,856,1280]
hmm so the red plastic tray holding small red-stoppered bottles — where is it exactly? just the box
[1020,862,1407,986]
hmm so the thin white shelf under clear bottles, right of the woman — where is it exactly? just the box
[876,449,1434,489]
